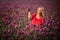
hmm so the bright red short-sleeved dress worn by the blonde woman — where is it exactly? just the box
[30,14,44,30]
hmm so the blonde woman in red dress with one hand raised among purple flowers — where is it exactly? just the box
[28,7,44,31]
